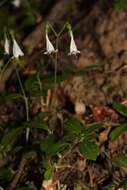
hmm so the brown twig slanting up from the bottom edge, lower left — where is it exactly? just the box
[8,158,26,190]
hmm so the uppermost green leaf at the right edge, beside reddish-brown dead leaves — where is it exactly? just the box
[112,103,127,118]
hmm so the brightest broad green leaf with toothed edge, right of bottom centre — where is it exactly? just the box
[79,142,99,161]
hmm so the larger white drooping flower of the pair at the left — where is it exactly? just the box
[13,38,24,58]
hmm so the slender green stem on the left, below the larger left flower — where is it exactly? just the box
[16,69,30,141]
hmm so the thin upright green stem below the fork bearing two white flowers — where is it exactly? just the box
[54,35,59,123]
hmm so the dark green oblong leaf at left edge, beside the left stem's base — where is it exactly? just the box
[1,127,23,148]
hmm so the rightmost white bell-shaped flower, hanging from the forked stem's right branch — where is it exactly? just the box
[68,32,80,55]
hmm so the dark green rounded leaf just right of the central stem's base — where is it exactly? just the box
[63,119,83,136]
